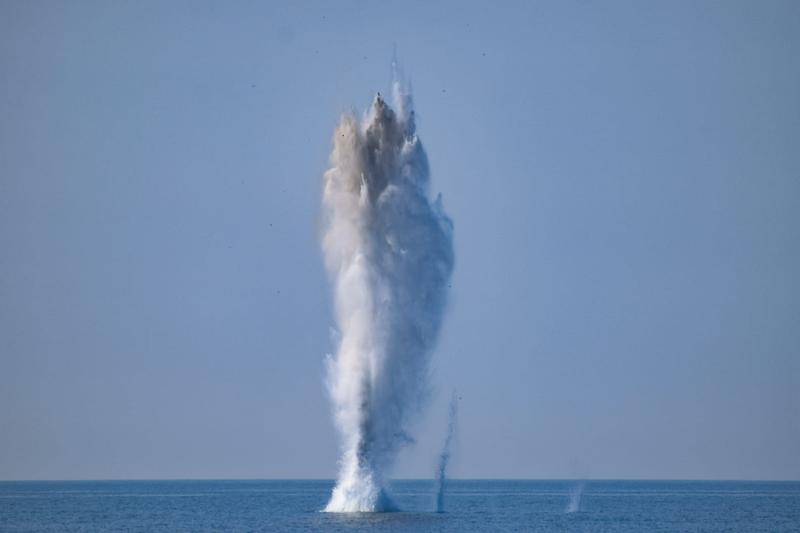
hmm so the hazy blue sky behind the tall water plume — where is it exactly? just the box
[0,0,800,479]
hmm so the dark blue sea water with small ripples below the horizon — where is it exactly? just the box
[0,481,800,533]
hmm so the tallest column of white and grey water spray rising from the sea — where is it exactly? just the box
[322,82,453,512]
